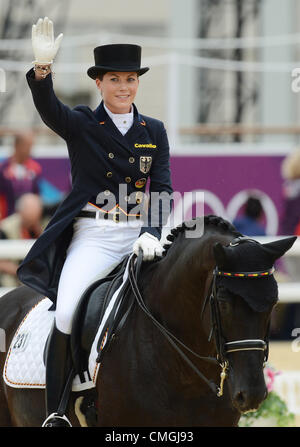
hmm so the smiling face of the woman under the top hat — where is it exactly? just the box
[96,72,139,113]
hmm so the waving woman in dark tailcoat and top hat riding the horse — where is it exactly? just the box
[18,17,172,426]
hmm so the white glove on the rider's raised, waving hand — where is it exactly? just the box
[32,17,63,64]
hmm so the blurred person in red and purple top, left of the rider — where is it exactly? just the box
[0,131,42,219]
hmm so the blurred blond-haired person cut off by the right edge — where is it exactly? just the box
[280,149,300,235]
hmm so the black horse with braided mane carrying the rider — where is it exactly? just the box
[0,216,296,427]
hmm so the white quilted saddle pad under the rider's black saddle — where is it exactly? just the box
[3,260,129,391]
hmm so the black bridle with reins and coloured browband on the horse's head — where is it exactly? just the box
[128,237,274,397]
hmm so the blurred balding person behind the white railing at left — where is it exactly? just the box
[0,193,47,287]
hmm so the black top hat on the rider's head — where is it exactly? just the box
[87,44,149,79]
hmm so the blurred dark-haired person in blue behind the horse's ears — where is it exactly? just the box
[233,196,266,236]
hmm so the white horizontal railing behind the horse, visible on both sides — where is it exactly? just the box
[0,236,300,303]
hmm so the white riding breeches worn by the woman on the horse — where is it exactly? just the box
[55,218,142,334]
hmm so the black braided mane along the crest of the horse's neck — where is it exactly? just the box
[164,214,243,254]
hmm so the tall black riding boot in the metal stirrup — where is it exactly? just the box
[43,324,72,427]
